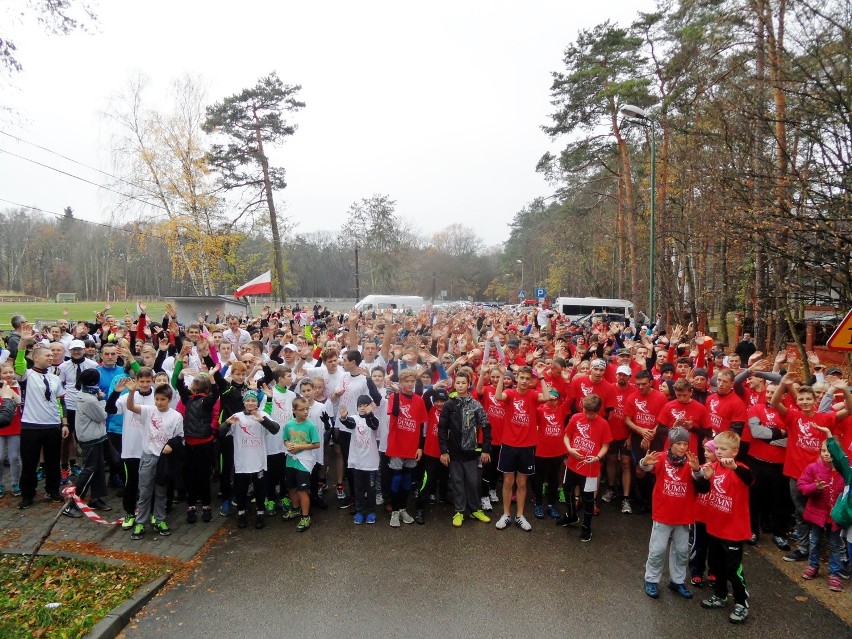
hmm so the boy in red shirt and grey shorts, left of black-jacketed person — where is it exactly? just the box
[387,368,428,528]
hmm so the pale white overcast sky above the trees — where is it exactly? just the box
[0,0,654,246]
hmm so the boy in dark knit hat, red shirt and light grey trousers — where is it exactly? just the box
[639,427,710,599]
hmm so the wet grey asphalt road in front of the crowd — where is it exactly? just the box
[124,503,852,639]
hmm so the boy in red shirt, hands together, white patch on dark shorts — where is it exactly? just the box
[556,394,612,542]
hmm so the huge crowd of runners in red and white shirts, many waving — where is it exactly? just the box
[0,303,852,623]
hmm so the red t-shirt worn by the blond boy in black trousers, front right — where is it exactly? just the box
[704,462,751,541]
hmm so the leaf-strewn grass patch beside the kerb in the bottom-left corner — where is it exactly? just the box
[0,555,165,639]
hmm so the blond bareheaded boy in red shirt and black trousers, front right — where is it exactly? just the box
[701,430,753,624]
